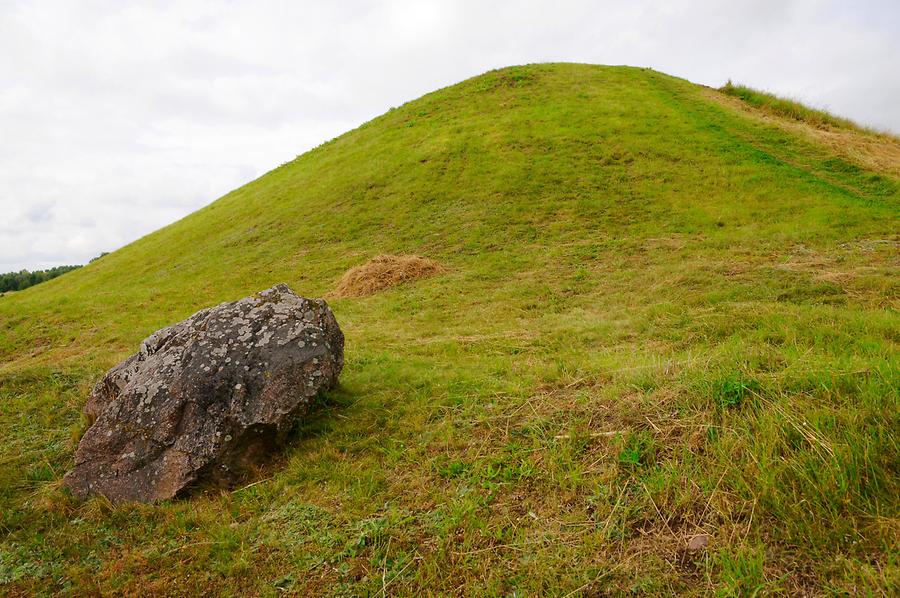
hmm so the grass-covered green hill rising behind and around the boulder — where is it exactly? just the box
[0,64,900,596]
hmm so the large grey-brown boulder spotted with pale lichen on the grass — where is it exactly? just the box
[65,284,344,502]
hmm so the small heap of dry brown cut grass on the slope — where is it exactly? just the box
[332,254,443,297]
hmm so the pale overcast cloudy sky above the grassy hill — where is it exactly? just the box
[0,0,900,272]
